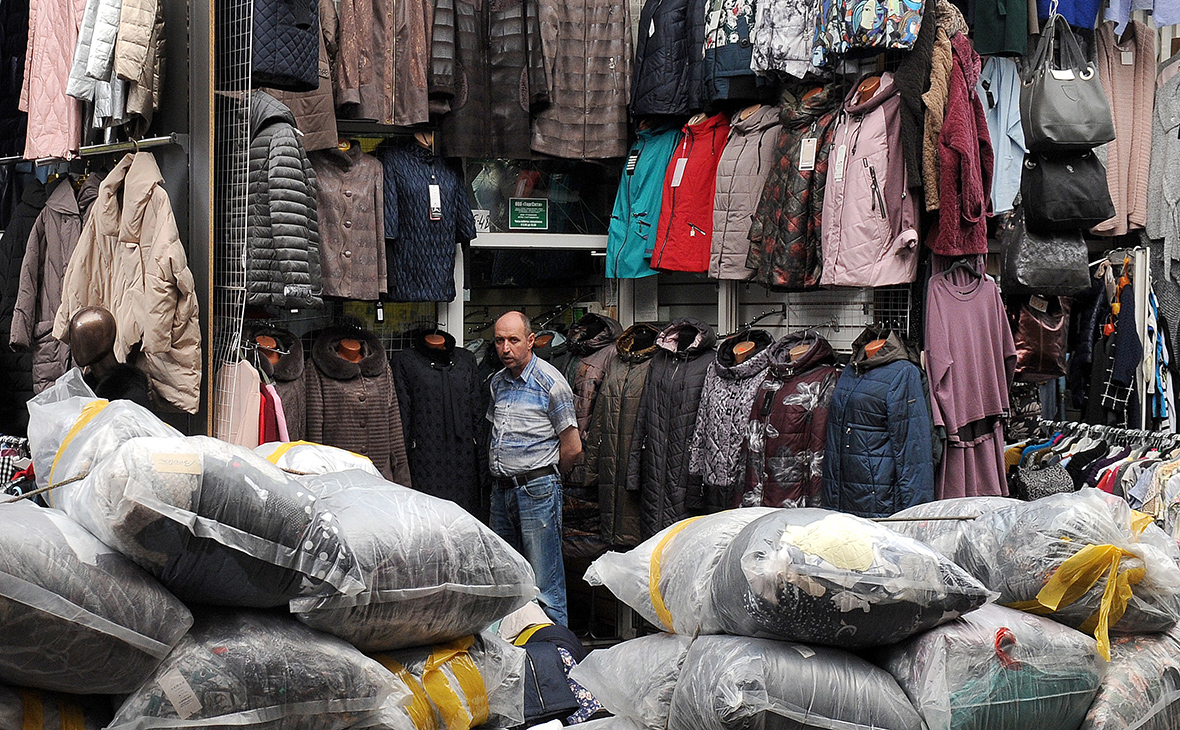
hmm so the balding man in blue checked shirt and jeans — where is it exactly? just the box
[487,311,582,626]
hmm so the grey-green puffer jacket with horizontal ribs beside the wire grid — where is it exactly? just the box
[245,92,323,309]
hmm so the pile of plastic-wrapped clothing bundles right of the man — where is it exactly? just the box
[571,497,1180,730]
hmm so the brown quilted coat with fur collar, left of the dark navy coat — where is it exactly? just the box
[303,327,412,487]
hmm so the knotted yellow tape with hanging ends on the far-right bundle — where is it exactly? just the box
[1008,545,1145,662]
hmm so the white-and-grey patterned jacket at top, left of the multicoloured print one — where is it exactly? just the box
[749,0,820,79]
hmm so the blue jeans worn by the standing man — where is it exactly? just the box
[492,474,569,626]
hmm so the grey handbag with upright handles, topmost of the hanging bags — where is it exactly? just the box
[1021,15,1114,152]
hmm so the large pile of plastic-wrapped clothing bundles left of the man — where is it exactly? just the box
[0,370,536,730]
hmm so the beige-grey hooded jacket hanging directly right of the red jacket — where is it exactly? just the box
[709,106,782,281]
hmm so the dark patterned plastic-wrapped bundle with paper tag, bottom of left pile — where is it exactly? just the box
[107,611,409,730]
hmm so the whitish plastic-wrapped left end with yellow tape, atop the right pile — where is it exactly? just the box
[585,507,774,636]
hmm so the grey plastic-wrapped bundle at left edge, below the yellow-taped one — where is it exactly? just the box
[0,501,192,695]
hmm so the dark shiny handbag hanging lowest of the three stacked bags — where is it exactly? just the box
[998,204,1090,296]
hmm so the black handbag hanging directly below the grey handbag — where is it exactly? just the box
[1021,150,1114,234]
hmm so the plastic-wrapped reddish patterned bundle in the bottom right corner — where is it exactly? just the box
[1077,629,1180,730]
